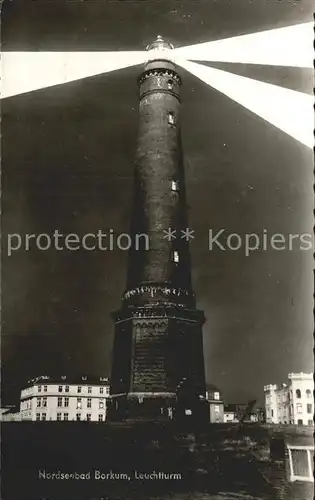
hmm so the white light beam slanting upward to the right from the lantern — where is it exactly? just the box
[175,23,314,68]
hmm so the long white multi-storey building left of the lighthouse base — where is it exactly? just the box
[20,375,109,422]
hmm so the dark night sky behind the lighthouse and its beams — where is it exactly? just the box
[2,0,313,403]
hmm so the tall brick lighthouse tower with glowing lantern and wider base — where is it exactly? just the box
[108,36,207,420]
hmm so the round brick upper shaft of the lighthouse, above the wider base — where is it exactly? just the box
[128,63,191,288]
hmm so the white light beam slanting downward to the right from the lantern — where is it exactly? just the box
[176,59,314,148]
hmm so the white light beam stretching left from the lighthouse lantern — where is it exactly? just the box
[0,51,146,99]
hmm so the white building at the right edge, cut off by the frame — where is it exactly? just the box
[264,372,314,425]
